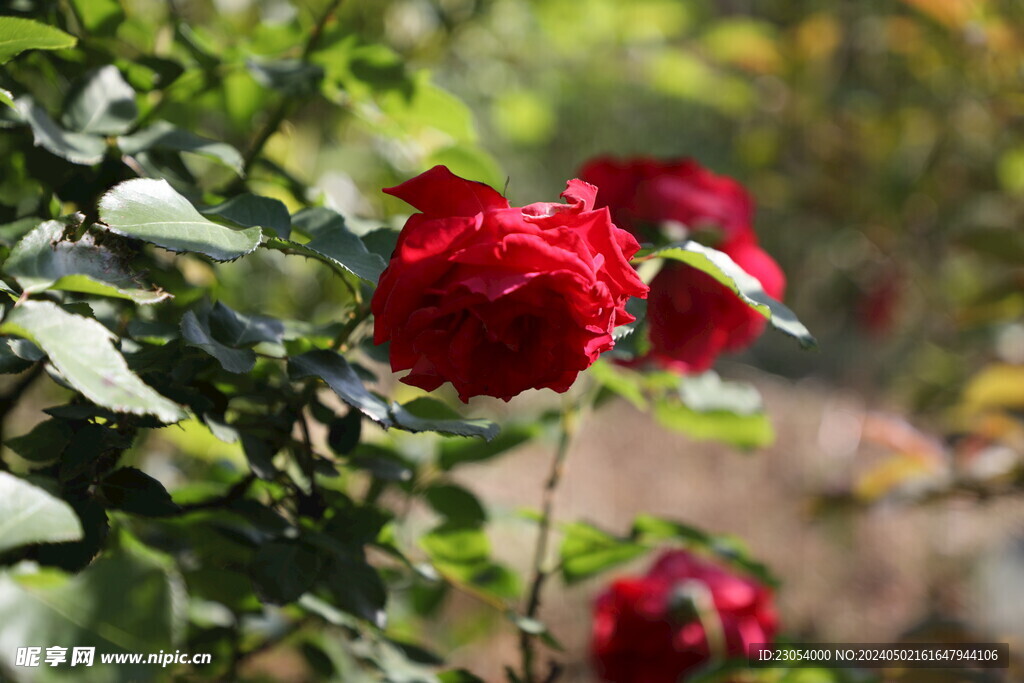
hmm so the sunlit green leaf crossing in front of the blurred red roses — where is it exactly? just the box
[638,240,817,348]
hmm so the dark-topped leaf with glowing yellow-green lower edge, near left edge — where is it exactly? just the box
[4,220,171,304]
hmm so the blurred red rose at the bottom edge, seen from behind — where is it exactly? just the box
[591,550,777,683]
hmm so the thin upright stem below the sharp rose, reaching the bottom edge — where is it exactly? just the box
[519,397,580,683]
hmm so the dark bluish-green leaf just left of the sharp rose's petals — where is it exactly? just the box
[266,207,386,285]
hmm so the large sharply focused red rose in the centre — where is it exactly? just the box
[371,166,647,401]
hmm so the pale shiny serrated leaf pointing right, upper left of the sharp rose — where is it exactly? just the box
[99,178,260,261]
